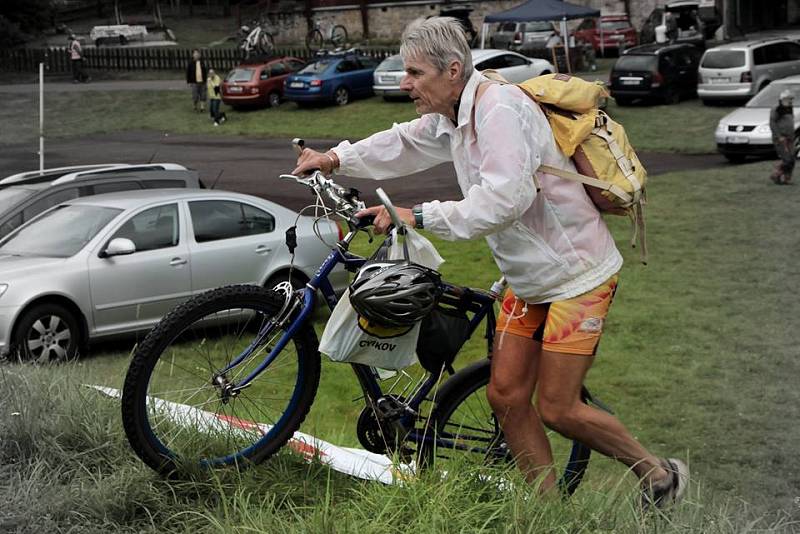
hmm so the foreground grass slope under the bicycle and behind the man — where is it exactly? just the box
[0,163,800,533]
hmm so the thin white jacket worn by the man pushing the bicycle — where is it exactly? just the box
[334,72,622,303]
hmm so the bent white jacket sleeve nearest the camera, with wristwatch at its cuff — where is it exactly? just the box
[422,101,536,240]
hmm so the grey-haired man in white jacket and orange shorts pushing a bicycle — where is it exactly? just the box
[295,18,688,506]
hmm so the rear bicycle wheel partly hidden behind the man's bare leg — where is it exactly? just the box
[420,359,591,495]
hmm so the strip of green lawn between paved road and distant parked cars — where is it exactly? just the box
[0,91,730,154]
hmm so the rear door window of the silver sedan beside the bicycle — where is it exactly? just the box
[189,200,275,243]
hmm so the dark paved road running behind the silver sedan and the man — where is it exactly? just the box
[0,132,728,209]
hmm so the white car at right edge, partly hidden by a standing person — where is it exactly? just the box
[714,76,800,162]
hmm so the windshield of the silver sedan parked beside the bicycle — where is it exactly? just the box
[0,205,122,258]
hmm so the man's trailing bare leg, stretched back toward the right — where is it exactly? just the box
[536,350,668,482]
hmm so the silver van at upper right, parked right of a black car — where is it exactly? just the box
[697,39,800,104]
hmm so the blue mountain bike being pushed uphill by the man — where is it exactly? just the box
[122,140,605,494]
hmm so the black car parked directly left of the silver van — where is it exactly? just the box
[609,44,700,106]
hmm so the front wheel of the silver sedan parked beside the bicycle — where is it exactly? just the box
[12,303,81,363]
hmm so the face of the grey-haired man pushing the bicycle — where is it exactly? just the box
[400,57,460,115]
